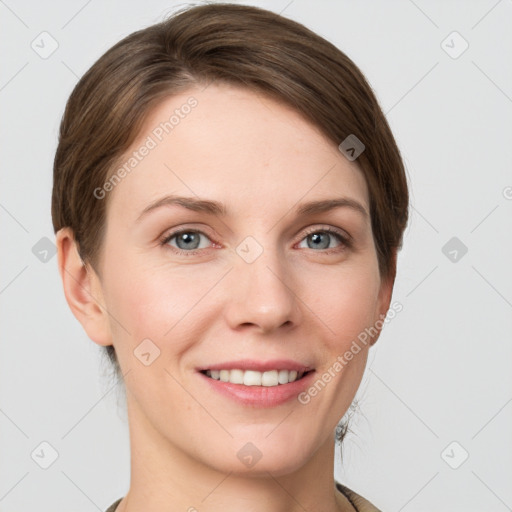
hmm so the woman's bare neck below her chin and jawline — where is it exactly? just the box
[116,399,353,512]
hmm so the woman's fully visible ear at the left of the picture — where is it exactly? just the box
[56,227,112,346]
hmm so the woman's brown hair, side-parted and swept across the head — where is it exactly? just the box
[52,3,409,440]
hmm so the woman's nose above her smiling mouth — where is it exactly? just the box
[224,242,302,334]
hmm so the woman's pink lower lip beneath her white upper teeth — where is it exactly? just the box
[198,371,315,407]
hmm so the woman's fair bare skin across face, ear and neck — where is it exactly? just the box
[57,84,394,512]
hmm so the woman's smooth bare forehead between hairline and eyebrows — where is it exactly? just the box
[106,83,368,220]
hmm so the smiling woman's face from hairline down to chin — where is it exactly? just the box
[87,84,392,475]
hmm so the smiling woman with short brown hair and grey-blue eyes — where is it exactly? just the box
[52,4,408,512]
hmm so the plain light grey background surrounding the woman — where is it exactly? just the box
[0,0,512,512]
